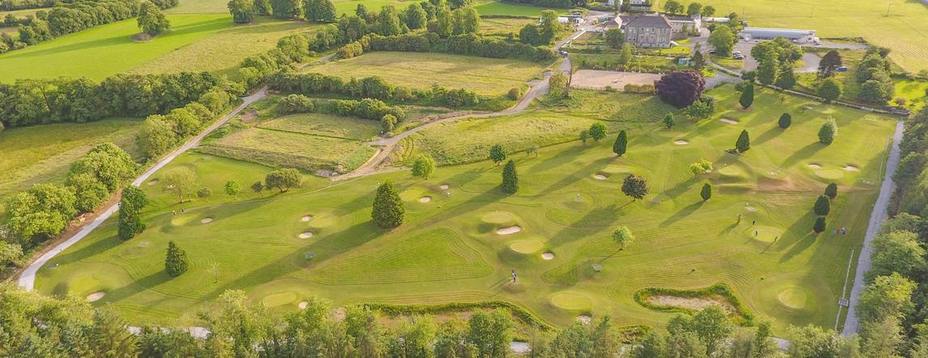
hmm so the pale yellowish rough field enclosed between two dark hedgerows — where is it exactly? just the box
[304,52,544,96]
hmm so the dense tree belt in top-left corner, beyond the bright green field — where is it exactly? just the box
[0,0,177,53]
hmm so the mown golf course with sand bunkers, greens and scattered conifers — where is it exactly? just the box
[36,86,895,330]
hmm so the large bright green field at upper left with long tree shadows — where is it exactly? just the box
[0,14,307,82]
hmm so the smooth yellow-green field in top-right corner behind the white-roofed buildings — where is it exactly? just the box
[692,0,928,73]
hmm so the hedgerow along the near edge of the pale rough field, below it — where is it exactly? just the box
[268,73,482,108]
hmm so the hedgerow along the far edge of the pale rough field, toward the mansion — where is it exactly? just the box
[338,32,556,62]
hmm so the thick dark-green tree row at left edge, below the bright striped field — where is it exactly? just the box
[0,72,223,127]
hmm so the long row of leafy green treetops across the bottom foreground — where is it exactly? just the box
[0,282,876,358]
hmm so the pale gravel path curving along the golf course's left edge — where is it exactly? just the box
[17,87,267,291]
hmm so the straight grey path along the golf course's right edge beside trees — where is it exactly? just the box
[842,121,904,336]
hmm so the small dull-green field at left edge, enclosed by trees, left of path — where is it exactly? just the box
[0,119,140,212]
